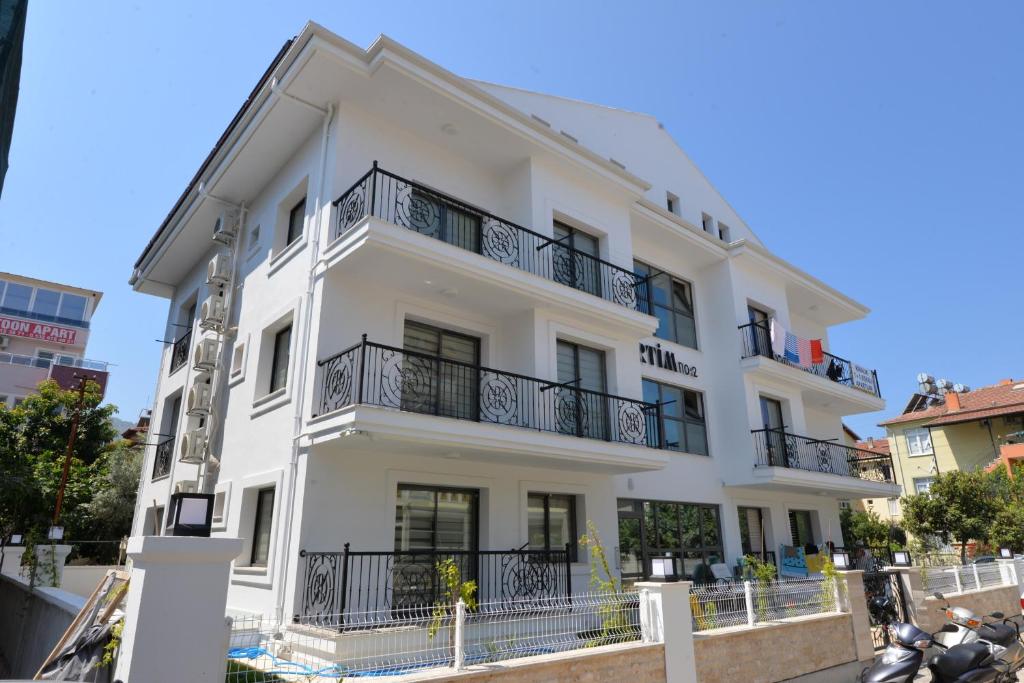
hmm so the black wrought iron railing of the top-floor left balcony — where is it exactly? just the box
[332,162,647,309]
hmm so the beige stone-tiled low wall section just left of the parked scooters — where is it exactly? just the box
[693,614,857,683]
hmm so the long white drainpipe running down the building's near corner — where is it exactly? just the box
[274,98,335,625]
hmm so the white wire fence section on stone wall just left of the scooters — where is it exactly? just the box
[690,579,840,632]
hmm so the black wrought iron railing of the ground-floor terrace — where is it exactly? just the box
[295,543,571,626]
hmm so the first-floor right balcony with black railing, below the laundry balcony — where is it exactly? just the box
[751,429,899,496]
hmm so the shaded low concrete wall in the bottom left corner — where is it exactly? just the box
[0,575,85,678]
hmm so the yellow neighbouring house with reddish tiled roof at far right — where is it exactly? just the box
[879,379,1024,518]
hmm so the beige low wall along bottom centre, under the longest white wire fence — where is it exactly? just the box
[410,643,666,683]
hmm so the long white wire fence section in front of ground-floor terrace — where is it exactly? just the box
[226,593,640,683]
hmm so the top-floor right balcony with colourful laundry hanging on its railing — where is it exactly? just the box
[738,323,885,415]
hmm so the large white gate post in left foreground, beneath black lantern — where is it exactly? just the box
[114,536,242,683]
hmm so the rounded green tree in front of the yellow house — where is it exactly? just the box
[901,470,999,562]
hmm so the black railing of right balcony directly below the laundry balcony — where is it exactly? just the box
[751,429,893,483]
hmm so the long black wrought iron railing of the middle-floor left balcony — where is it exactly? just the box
[313,335,662,449]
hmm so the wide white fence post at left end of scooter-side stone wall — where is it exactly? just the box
[636,581,697,683]
